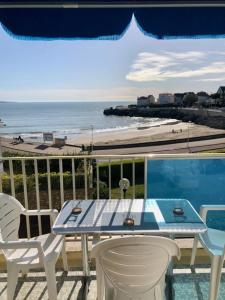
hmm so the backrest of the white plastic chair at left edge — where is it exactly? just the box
[0,193,24,242]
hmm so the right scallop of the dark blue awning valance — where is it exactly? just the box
[135,7,225,39]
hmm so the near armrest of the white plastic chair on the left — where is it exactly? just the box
[0,240,44,260]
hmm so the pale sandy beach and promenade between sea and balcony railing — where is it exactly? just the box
[1,121,225,155]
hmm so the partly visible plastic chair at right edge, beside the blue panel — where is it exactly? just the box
[191,205,225,300]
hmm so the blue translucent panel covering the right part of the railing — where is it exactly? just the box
[147,159,225,230]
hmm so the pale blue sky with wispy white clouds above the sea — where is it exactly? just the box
[0,19,225,102]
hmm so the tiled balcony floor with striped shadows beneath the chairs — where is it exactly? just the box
[0,266,225,300]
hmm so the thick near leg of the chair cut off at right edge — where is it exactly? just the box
[209,256,220,300]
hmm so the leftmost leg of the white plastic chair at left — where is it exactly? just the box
[7,263,19,300]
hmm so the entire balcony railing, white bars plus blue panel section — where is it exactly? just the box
[0,154,225,237]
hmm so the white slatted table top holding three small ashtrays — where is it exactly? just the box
[53,199,207,234]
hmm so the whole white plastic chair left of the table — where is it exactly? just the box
[0,193,68,300]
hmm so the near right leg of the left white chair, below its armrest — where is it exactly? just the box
[44,262,57,300]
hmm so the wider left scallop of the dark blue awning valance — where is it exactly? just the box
[0,8,133,39]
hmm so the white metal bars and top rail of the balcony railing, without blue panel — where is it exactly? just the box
[0,154,225,237]
